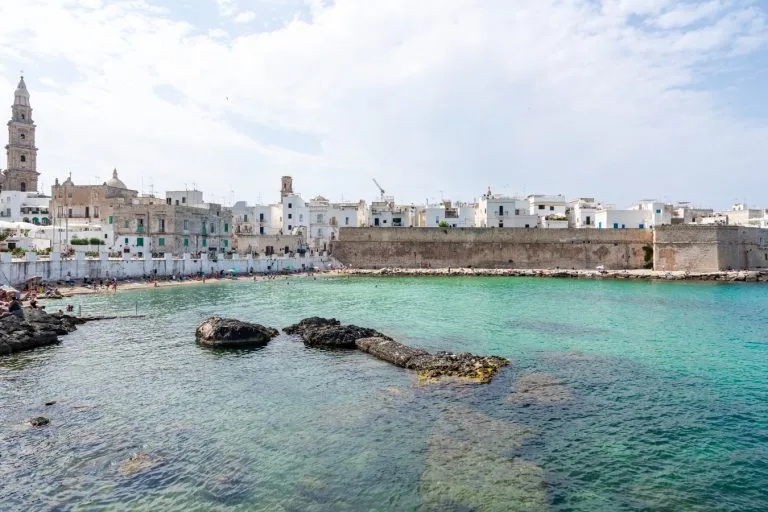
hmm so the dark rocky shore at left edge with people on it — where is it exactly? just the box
[0,309,83,355]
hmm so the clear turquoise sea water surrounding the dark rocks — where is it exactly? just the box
[0,278,768,511]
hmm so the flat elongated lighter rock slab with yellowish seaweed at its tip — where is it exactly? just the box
[357,338,509,384]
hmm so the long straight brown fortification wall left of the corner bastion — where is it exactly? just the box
[331,228,653,269]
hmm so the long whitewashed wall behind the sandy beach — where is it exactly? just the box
[0,253,334,286]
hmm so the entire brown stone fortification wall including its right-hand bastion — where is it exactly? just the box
[331,226,768,272]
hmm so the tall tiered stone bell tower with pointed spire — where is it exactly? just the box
[3,76,40,192]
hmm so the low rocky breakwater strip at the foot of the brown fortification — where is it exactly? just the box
[332,268,768,283]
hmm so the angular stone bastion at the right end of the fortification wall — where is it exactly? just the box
[653,226,768,272]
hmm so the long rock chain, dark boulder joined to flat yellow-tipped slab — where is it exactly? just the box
[283,317,509,384]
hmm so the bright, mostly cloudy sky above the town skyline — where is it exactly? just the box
[0,0,768,209]
